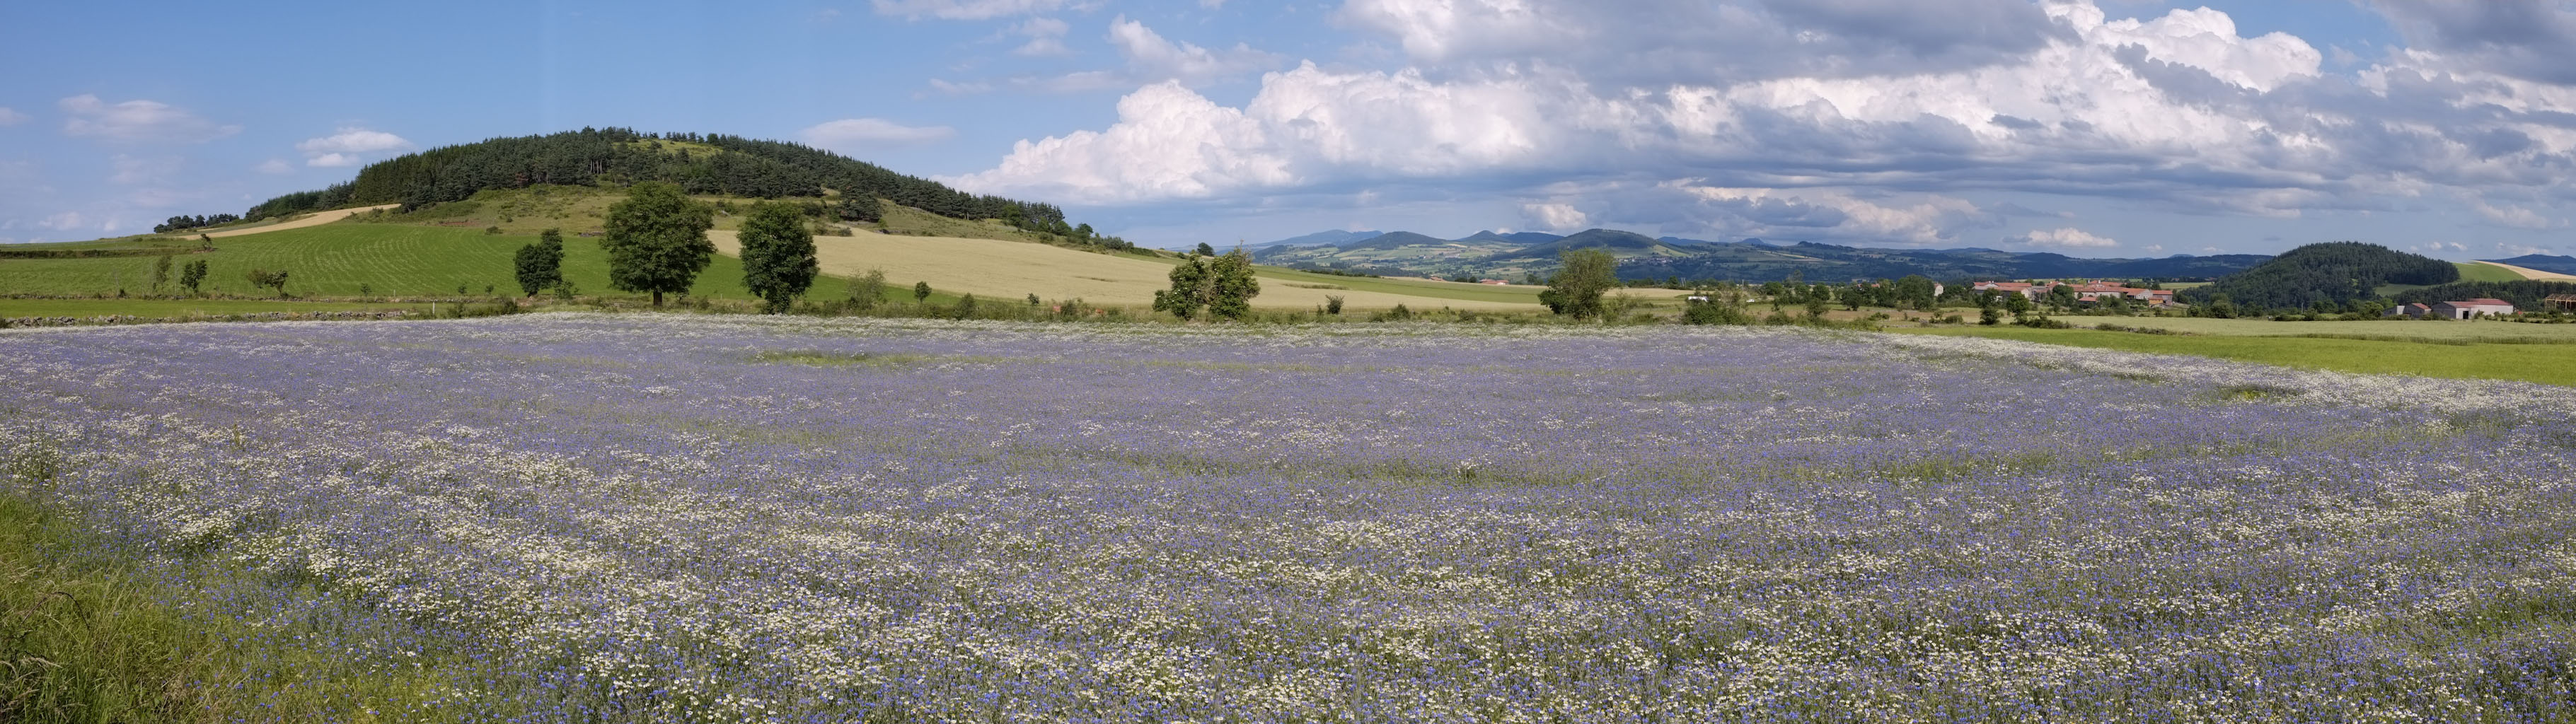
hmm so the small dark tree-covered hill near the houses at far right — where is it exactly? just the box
[2182,243,2460,309]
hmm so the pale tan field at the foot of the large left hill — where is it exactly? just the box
[706,232,1538,312]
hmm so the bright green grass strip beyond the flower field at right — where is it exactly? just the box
[1898,322,2576,387]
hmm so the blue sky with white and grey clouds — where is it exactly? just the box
[0,0,2576,260]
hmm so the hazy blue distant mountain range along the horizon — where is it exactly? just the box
[1247,229,2277,281]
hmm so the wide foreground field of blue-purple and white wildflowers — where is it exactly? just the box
[0,315,2576,721]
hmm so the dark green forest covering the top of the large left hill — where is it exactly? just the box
[242,129,1064,229]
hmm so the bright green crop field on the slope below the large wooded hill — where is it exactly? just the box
[0,221,848,303]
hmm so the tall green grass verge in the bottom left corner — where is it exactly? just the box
[0,489,479,724]
